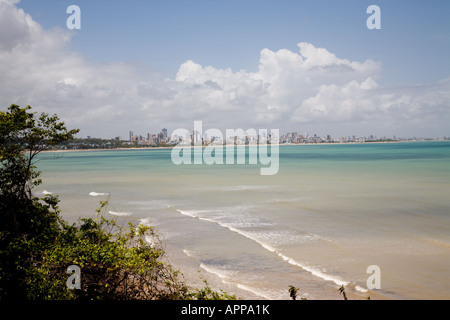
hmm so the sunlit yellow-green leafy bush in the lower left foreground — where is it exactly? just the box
[28,202,192,300]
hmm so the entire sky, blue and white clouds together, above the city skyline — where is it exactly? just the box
[0,0,450,138]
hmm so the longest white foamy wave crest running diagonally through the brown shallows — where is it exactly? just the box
[177,209,367,292]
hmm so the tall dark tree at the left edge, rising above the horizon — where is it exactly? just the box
[0,104,78,298]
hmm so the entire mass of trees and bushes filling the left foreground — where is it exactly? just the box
[0,105,235,301]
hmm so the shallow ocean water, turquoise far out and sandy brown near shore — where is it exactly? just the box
[35,141,450,300]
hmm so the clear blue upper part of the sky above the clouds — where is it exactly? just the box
[19,0,450,85]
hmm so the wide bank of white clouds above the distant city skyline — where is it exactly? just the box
[0,0,450,137]
